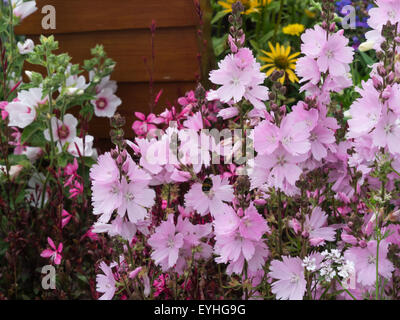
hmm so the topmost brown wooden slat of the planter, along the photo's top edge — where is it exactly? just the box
[16,0,198,34]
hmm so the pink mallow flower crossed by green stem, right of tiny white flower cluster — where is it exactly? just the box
[344,240,394,286]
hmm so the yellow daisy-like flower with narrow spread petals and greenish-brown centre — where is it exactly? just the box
[259,42,300,84]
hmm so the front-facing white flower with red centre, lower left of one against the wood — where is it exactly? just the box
[44,113,78,146]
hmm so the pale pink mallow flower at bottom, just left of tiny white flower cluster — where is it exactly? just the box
[268,256,307,300]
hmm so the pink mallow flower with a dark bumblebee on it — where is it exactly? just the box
[185,175,234,217]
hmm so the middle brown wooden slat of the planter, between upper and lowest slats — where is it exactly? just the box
[26,27,199,82]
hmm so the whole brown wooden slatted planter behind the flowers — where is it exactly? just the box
[16,0,208,145]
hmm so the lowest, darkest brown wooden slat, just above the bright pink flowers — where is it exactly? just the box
[81,82,196,138]
